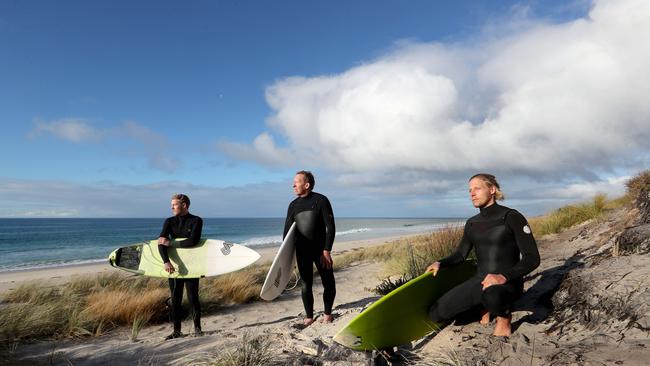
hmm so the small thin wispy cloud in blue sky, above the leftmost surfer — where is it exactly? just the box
[28,118,182,173]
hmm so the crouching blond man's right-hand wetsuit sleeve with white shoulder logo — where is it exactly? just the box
[502,210,540,281]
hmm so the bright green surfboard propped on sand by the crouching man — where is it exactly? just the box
[334,261,476,351]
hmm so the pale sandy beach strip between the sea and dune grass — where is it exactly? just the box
[0,231,433,294]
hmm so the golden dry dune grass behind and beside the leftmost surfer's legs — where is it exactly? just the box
[0,265,268,344]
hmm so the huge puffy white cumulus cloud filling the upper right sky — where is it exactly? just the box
[222,0,650,181]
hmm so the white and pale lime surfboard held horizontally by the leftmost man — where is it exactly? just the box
[108,239,260,278]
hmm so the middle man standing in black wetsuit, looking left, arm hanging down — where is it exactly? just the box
[283,170,336,325]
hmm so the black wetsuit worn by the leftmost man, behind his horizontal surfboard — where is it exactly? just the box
[158,213,203,333]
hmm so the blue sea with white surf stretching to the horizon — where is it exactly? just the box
[0,218,464,272]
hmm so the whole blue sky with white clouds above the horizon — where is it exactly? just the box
[0,0,650,217]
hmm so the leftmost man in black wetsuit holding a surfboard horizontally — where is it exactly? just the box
[158,194,203,339]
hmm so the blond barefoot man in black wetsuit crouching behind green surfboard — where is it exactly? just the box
[427,174,539,336]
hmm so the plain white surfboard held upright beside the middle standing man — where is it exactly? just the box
[260,222,296,301]
